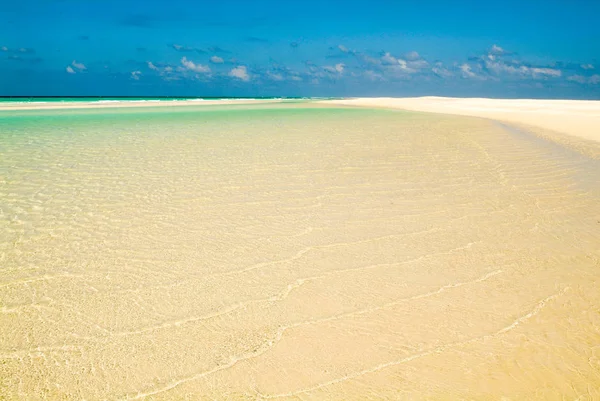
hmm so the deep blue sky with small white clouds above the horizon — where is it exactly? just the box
[0,0,600,99]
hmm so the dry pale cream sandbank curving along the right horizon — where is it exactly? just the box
[325,96,600,142]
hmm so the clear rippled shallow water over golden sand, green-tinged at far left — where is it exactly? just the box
[0,105,600,400]
